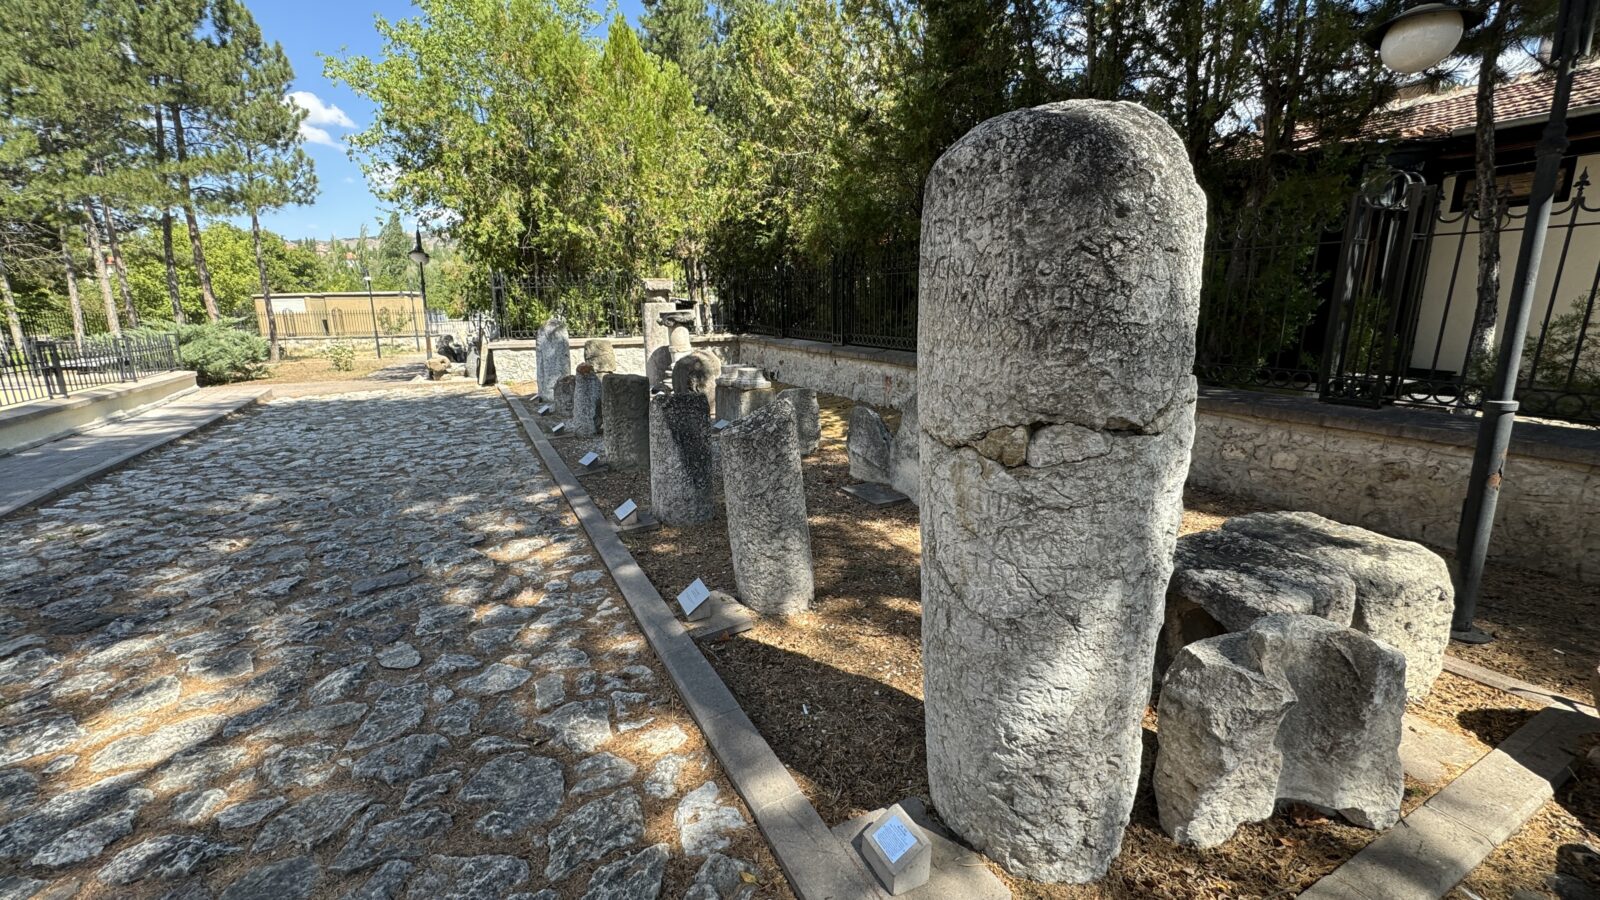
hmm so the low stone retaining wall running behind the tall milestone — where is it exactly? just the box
[738,335,1600,583]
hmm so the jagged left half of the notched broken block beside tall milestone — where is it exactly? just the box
[1155,634,1294,849]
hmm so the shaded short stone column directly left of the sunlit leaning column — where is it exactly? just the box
[650,394,715,525]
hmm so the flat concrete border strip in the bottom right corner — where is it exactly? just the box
[1301,708,1600,900]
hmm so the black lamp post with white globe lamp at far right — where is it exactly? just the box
[1365,0,1600,644]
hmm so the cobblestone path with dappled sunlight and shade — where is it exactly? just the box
[0,389,774,900]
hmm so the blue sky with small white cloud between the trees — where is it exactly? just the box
[242,0,642,239]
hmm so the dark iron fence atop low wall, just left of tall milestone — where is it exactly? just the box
[709,250,917,351]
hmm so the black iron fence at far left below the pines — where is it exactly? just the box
[0,331,179,407]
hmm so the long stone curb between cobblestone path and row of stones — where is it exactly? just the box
[498,386,888,900]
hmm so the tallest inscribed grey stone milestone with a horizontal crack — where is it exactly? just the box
[917,101,1205,882]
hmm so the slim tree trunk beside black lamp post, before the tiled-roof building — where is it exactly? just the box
[1461,11,1506,383]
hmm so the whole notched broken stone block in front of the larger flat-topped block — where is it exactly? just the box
[1155,615,1405,847]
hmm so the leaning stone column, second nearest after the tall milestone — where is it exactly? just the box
[720,399,814,615]
